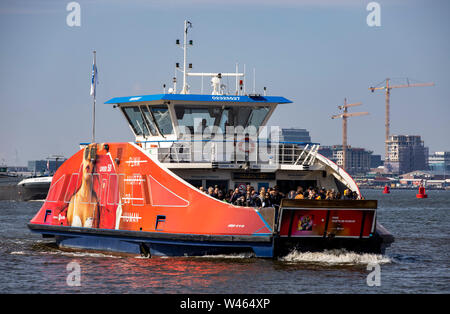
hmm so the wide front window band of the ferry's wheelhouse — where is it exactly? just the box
[175,105,270,133]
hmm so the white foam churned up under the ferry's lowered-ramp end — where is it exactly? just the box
[280,249,391,265]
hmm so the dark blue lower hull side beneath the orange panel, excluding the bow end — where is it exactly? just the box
[28,224,274,257]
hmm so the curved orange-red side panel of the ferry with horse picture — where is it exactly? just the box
[30,143,272,235]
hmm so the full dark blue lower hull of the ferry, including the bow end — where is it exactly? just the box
[29,224,393,258]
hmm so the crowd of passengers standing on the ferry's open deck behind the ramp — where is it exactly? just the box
[199,185,358,207]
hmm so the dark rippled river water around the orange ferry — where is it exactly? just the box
[0,190,450,294]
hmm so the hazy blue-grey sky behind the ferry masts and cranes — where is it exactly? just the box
[0,0,450,165]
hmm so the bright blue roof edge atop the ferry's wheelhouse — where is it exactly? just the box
[105,94,292,104]
